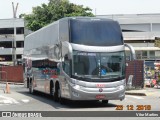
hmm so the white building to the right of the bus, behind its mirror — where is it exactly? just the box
[98,14,160,60]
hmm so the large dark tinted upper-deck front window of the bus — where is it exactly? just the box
[70,19,123,46]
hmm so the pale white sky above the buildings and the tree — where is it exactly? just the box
[0,0,160,19]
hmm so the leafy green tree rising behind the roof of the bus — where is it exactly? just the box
[20,0,94,31]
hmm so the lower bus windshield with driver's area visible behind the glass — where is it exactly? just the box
[72,51,125,81]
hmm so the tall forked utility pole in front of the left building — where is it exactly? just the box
[12,2,18,66]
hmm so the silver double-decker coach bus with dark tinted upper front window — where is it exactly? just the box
[24,17,134,103]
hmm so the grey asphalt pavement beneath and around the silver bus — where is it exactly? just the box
[0,83,160,120]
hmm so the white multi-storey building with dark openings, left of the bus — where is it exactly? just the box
[0,19,24,65]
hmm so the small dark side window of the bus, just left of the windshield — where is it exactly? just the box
[62,55,70,76]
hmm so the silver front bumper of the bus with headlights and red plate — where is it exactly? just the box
[70,85,125,100]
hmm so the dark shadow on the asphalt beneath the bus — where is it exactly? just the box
[17,91,116,110]
